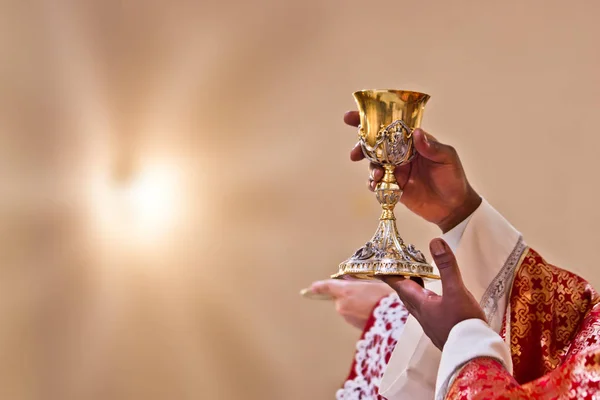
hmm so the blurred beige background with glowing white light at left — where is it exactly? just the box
[0,0,600,400]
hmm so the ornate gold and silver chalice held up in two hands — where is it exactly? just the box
[332,90,439,279]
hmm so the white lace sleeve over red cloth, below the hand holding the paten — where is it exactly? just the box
[336,293,408,400]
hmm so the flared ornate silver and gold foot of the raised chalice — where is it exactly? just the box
[331,219,440,280]
